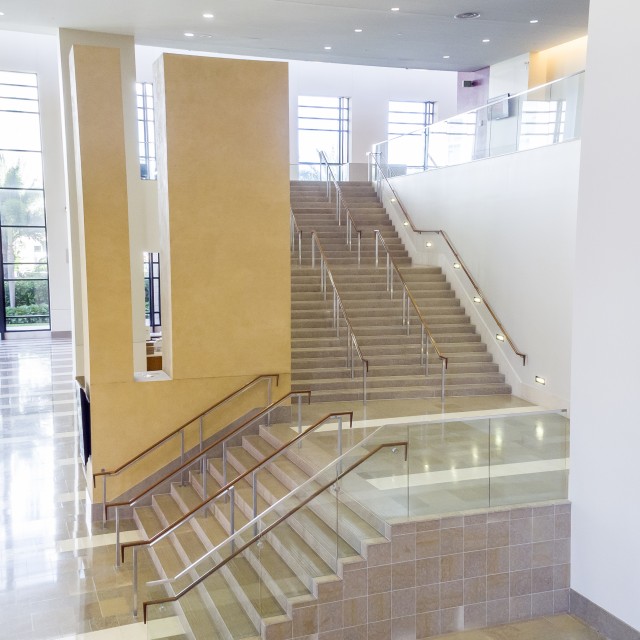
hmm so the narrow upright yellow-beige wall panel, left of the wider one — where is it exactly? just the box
[71,46,133,385]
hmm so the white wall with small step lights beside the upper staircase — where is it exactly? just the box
[384,142,580,408]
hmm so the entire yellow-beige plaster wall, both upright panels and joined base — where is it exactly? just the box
[71,46,290,500]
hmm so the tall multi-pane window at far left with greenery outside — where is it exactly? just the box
[0,71,51,333]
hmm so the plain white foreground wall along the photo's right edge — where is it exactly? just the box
[570,0,640,630]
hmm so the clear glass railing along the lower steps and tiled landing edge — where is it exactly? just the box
[144,409,569,638]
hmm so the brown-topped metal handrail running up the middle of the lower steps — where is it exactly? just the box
[121,411,353,616]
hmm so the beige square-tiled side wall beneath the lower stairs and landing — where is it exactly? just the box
[284,501,571,640]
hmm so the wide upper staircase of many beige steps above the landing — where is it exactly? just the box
[291,181,511,401]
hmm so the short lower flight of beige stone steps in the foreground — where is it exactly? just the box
[134,424,388,640]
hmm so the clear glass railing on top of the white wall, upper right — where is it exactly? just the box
[374,71,584,177]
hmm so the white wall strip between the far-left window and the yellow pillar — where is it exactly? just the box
[0,31,71,331]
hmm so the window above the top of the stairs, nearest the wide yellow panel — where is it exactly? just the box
[298,96,351,180]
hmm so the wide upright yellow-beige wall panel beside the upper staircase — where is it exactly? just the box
[156,55,291,379]
